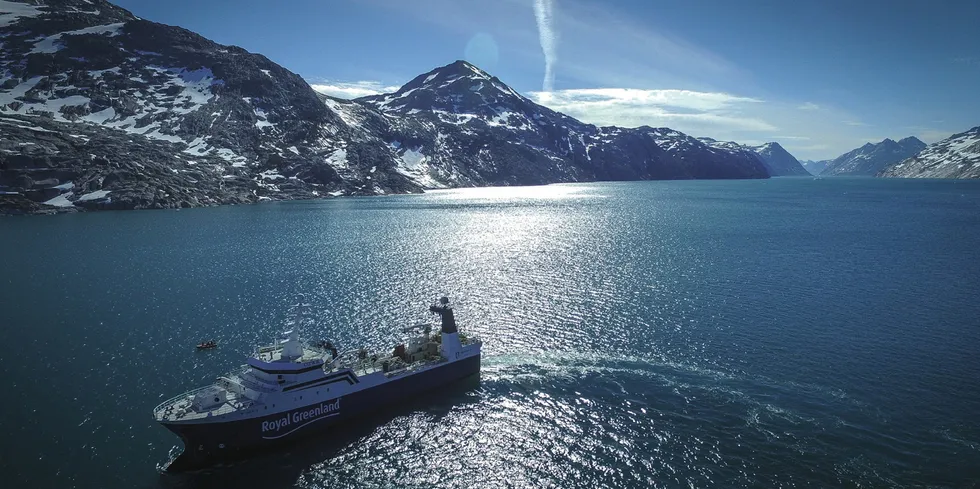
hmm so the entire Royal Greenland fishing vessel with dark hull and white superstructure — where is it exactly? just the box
[153,297,482,471]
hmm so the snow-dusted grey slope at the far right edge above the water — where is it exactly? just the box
[879,126,980,178]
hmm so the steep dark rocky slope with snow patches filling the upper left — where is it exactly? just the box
[0,0,421,209]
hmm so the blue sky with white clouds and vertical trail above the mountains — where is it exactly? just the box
[115,0,980,160]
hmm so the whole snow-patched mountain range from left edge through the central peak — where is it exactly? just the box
[0,0,768,212]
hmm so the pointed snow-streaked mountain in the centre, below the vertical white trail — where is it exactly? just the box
[348,61,767,186]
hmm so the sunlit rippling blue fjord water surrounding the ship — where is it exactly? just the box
[0,178,980,488]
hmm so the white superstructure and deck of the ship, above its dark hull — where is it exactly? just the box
[153,302,481,426]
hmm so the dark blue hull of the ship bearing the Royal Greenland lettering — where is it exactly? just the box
[163,355,480,472]
